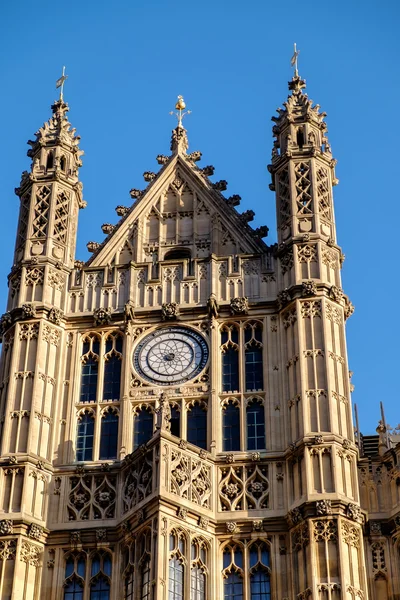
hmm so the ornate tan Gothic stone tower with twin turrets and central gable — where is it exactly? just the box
[0,75,394,600]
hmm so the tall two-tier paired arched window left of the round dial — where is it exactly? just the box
[75,332,123,461]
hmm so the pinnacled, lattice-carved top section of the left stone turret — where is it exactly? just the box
[14,69,86,282]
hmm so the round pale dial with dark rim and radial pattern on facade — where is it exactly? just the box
[133,327,208,385]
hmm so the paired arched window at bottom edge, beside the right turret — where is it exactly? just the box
[222,540,271,600]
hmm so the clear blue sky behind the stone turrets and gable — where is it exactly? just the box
[0,0,400,433]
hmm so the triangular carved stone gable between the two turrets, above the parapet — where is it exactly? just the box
[89,138,267,266]
